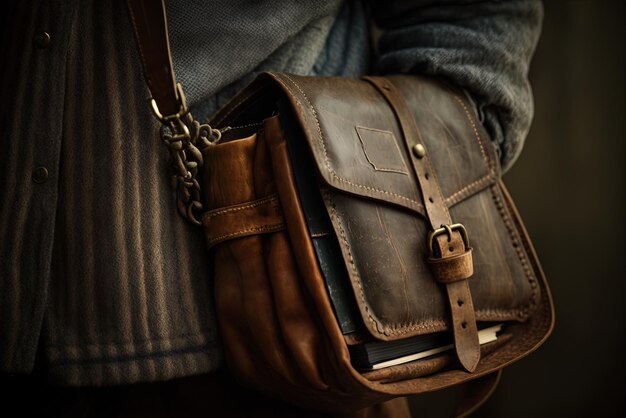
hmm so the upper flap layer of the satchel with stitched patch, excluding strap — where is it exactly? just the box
[212,73,499,215]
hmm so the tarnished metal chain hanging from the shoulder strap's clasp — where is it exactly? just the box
[161,112,222,222]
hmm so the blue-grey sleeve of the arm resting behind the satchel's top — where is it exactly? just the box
[372,0,543,170]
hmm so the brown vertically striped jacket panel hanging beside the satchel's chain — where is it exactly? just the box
[42,2,219,384]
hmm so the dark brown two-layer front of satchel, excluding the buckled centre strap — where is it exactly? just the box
[213,74,540,340]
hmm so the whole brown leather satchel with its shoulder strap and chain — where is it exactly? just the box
[128,0,554,411]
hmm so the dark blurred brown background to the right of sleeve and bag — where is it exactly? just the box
[414,0,626,418]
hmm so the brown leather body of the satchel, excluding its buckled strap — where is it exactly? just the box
[203,73,553,409]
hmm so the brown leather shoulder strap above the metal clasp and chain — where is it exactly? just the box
[126,0,185,119]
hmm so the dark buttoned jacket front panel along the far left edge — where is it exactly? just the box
[0,2,71,372]
